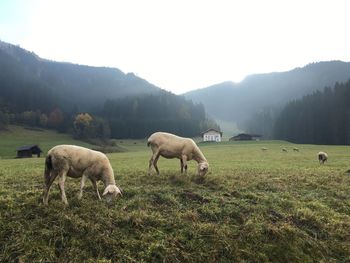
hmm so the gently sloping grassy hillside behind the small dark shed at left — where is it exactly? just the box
[0,126,93,158]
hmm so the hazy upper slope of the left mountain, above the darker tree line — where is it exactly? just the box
[0,41,160,112]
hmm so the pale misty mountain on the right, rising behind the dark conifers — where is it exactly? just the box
[184,61,350,127]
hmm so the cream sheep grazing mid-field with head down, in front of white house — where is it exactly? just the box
[147,132,209,176]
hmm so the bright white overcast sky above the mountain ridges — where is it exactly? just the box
[0,0,350,94]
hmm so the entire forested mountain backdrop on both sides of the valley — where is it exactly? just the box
[0,41,350,144]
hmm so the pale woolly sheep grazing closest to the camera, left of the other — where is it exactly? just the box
[43,145,122,205]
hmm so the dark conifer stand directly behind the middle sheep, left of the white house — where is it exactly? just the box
[100,91,219,138]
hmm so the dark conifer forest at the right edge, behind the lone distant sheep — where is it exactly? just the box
[274,80,350,145]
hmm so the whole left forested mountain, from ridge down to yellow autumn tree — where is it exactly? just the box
[0,42,218,140]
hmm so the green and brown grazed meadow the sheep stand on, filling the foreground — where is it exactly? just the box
[0,129,350,262]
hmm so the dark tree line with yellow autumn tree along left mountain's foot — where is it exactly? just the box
[0,87,219,139]
